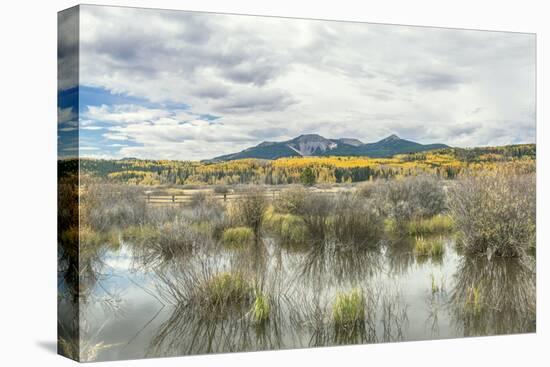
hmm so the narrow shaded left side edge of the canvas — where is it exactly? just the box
[57,6,80,360]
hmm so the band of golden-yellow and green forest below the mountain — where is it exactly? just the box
[67,144,536,185]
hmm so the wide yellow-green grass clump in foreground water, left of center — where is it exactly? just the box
[201,272,252,307]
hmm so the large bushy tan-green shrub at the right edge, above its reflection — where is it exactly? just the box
[451,172,536,257]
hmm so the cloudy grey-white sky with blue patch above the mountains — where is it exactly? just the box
[58,6,536,160]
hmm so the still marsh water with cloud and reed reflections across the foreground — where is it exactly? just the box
[59,230,535,360]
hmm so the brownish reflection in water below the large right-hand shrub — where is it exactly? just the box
[450,257,536,336]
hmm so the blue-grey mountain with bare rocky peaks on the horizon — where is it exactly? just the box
[211,134,448,161]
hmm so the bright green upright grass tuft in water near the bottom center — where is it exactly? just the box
[332,288,366,328]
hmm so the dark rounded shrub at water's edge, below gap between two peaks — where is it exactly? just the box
[331,194,384,246]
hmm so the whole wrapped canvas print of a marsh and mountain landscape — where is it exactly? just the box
[57,5,536,362]
